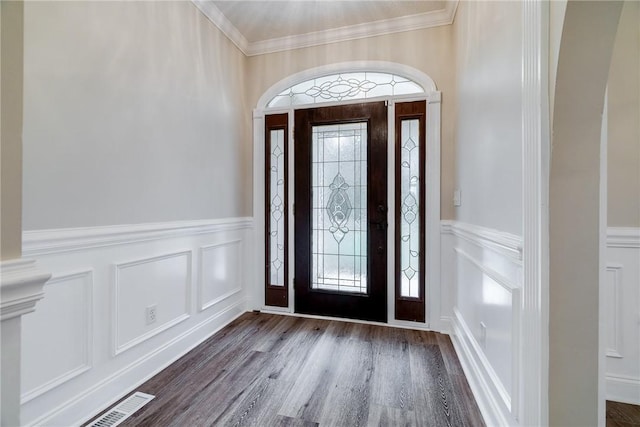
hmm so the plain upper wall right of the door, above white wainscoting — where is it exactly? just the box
[454,1,522,235]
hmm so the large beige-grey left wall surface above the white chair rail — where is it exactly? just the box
[23,1,252,230]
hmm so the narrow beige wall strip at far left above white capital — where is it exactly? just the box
[0,1,24,260]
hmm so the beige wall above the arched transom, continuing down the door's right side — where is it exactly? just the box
[247,25,455,219]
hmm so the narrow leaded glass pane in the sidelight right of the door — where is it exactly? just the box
[398,119,422,298]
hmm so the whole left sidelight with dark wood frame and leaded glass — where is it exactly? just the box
[265,114,289,307]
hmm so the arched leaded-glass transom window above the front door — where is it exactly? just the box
[267,72,424,107]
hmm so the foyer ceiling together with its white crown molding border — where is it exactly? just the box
[192,0,457,55]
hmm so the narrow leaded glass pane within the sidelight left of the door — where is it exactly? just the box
[268,129,285,286]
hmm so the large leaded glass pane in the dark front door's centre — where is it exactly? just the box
[311,123,367,293]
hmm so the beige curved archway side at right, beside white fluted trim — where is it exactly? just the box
[549,1,622,426]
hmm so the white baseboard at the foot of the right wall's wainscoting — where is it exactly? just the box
[450,311,518,426]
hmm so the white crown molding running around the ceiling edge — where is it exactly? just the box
[191,0,459,56]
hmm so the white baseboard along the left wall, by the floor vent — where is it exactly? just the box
[29,299,246,426]
